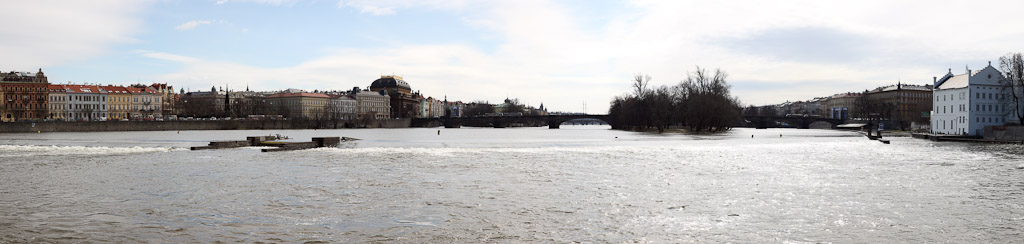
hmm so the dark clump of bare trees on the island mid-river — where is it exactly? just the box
[608,67,742,133]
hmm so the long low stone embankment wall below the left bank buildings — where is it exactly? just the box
[0,119,410,133]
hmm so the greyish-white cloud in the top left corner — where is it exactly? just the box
[0,0,150,71]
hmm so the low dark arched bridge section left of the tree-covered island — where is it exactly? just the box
[412,115,615,129]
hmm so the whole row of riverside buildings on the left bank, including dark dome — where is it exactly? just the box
[0,69,547,122]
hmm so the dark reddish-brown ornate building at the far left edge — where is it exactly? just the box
[0,69,50,122]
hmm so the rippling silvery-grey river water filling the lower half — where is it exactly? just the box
[0,126,1024,243]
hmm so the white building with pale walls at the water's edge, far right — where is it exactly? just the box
[931,63,1015,136]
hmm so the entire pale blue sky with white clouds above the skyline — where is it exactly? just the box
[0,0,1024,114]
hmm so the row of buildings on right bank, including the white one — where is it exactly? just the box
[746,63,1024,135]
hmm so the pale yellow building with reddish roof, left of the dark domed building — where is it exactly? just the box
[266,92,331,119]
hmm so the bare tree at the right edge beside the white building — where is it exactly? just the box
[999,52,1024,123]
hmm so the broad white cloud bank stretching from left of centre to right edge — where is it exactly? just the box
[141,0,1024,113]
